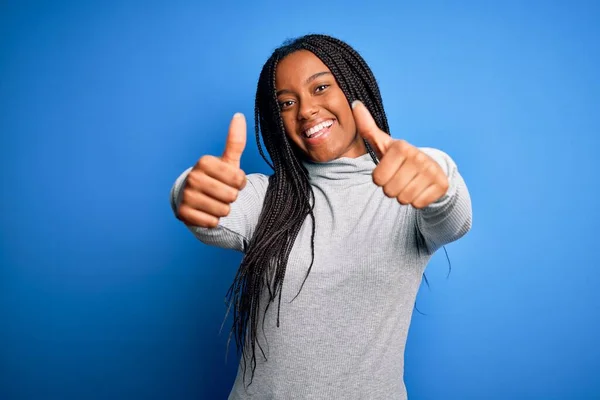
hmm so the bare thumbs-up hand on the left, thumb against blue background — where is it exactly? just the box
[178,113,246,228]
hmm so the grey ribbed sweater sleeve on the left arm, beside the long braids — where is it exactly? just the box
[170,168,269,252]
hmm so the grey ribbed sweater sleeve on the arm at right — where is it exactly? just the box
[416,147,473,254]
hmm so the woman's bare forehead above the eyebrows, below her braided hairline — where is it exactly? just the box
[275,50,331,89]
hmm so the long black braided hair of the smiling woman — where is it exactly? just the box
[227,34,389,383]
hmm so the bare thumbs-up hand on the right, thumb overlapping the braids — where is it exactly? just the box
[352,101,449,208]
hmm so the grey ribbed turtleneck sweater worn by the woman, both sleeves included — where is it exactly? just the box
[171,148,472,400]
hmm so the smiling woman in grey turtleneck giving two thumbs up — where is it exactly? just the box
[171,35,471,400]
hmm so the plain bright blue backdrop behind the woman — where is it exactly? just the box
[0,0,600,399]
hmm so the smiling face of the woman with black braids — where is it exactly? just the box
[275,50,367,162]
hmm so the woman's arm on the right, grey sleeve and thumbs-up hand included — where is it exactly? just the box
[352,101,472,253]
